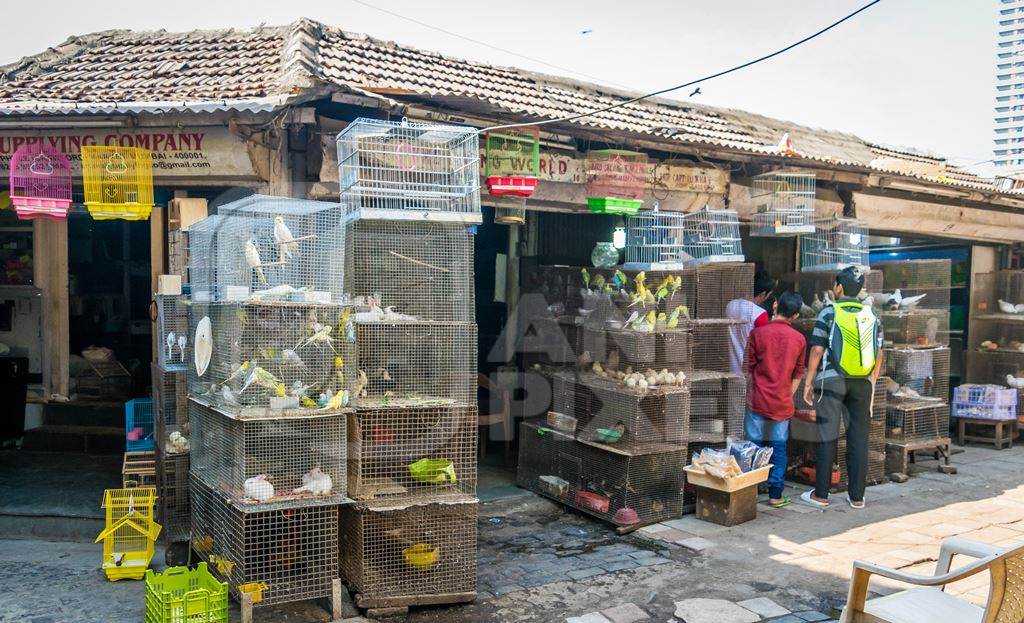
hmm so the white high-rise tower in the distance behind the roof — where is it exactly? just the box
[993,0,1024,168]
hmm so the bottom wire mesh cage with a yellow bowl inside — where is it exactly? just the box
[337,496,477,608]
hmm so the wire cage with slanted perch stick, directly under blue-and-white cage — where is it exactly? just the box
[345,219,475,323]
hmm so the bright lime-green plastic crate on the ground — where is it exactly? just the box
[145,563,227,623]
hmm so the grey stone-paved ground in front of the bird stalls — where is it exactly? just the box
[0,448,1024,623]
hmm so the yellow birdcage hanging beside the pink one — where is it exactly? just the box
[82,146,153,220]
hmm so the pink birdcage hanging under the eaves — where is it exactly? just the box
[10,142,71,220]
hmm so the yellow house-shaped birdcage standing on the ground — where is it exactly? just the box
[96,487,160,582]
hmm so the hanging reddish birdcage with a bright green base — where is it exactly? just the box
[585,150,647,215]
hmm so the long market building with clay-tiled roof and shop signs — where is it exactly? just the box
[0,14,1024,618]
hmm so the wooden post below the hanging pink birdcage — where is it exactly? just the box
[32,218,71,399]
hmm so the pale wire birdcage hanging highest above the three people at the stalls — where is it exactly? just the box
[751,170,815,237]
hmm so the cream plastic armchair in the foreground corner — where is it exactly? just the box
[842,537,1024,623]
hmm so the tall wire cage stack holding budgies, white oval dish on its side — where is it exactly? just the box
[185,195,357,607]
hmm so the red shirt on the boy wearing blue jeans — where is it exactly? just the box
[746,320,807,420]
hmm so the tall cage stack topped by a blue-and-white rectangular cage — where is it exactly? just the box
[337,119,480,609]
